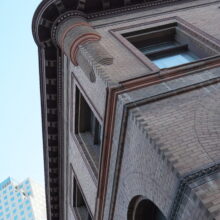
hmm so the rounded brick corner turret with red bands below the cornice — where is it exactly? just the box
[56,16,113,82]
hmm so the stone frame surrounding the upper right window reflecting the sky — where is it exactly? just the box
[109,16,220,74]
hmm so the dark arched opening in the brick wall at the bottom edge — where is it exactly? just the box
[128,196,166,220]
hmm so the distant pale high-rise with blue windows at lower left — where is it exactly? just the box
[0,177,47,220]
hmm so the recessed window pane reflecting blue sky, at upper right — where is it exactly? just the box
[123,23,215,69]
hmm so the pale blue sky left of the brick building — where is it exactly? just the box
[0,0,44,184]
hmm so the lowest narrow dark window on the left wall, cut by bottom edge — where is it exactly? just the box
[72,177,92,220]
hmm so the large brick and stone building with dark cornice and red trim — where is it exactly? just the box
[32,0,220,220]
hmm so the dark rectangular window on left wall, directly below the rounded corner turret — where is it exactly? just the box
[75,87,101,170]
